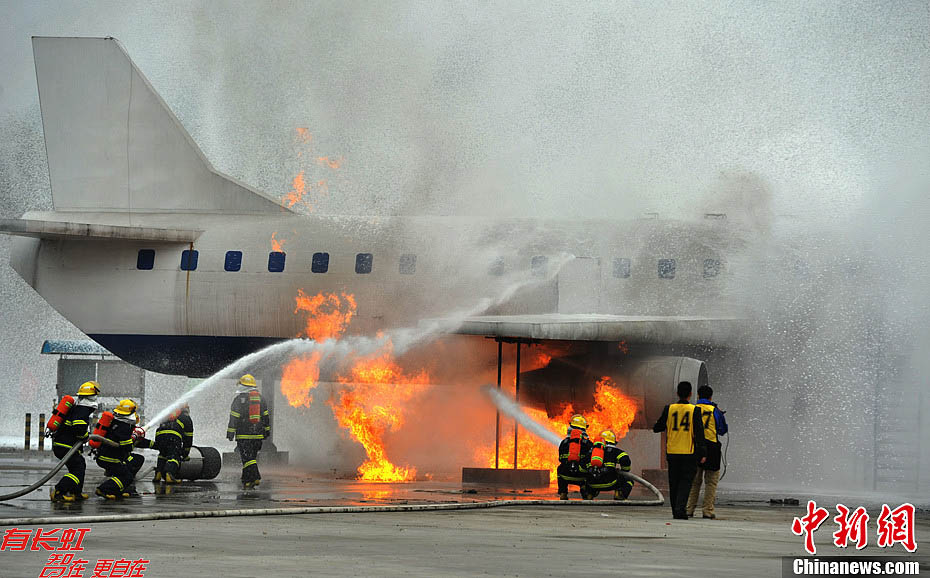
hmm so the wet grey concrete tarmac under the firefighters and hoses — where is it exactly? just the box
[0,464,930,578]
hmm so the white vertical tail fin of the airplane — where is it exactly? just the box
[32,37,287,214]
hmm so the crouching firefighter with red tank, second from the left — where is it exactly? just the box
[88,399,145,500]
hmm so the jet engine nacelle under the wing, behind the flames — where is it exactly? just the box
[520,355,708,429]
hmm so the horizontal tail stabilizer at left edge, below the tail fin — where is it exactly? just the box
[0,219,203,243]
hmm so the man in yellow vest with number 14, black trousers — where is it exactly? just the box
[652,381,707,520]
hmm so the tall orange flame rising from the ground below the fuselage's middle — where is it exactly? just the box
[329,346,429,482]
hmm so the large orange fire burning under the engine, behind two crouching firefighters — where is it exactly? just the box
[477,376,636,481]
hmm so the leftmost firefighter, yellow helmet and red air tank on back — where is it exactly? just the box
[45,381,100,502]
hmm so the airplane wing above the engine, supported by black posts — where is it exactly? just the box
[442,313,749,347]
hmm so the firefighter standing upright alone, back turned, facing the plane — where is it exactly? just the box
[226,373,271,490]
